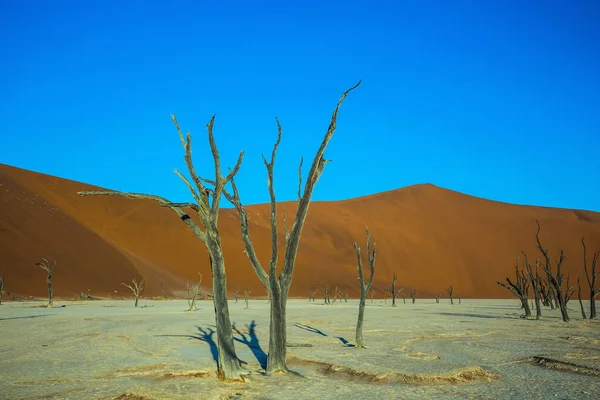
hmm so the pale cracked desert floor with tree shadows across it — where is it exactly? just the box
[0,299,600,400]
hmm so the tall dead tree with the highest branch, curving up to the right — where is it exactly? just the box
[223,81,360,374]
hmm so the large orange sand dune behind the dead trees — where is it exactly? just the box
[0,164,600,298]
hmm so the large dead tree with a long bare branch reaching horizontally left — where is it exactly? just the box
[78,115,248,380]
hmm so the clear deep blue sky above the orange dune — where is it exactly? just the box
[0,0,600,211]
